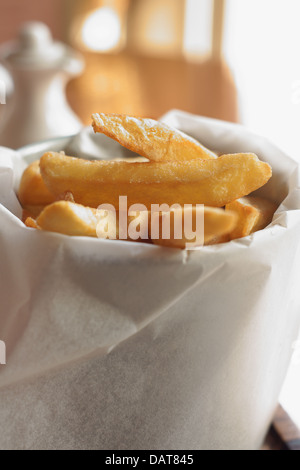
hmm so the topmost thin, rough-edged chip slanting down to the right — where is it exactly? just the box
[92,113,216,162]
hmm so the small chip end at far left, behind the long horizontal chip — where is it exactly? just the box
[18,160,55,207]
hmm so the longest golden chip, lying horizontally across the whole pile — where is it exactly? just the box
[40,152,272,210]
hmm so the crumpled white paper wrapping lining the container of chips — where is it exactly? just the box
[0,111,300,450]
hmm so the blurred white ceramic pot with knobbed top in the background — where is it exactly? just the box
[0,23,83,148]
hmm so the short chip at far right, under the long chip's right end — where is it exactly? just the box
[226,196,278,240]
